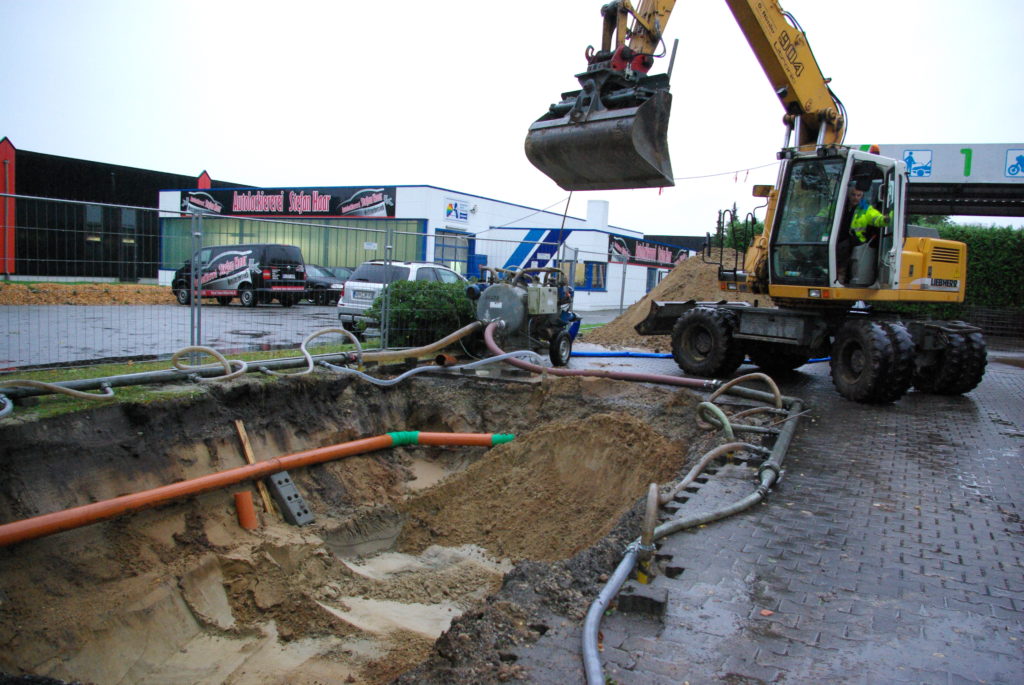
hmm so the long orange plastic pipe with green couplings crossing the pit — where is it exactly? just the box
[0,431,514,547]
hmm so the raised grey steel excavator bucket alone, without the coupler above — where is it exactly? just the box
[526,89,675,190]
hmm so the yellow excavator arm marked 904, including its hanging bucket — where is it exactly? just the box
[525,0,846,190]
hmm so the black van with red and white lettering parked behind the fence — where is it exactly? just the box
[171,243,306,307]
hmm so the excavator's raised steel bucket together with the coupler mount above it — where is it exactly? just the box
[525,69,675,190]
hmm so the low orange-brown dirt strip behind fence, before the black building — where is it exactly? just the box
[0,282,175,305]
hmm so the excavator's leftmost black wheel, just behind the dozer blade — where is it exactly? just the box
[672,307,743,378]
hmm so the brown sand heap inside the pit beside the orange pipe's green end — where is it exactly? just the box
[399,414,680,561]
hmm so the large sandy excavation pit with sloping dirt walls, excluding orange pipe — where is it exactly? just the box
[0,375,708,684]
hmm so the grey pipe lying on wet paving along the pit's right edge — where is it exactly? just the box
[583,393,804,685]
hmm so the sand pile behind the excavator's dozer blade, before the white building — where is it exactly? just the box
[581,251,768,352]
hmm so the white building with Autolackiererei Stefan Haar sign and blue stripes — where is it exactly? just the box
[159,185,688,310]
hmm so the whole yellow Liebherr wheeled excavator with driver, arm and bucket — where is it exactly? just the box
[525,0,986,403]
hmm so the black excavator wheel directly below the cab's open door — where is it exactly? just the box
[830,318,894,404]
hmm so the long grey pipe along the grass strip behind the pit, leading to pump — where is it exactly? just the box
[0,322,483,401]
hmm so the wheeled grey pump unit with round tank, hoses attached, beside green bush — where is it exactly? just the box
[466,266,582,367]
